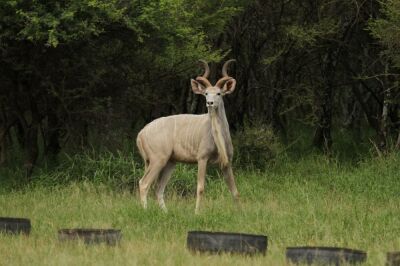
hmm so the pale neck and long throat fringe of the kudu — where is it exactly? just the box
[209,102,233,166]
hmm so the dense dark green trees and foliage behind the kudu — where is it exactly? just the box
[0,0,400,176]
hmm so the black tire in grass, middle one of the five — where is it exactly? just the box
[187,231,268,255]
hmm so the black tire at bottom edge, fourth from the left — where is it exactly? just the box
[286,247,367,266]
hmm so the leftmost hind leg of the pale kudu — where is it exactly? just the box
[139,160,166,209]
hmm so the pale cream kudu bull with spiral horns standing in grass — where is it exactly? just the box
[136,60,239,214]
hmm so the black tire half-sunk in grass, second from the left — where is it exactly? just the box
[58,228,122,246]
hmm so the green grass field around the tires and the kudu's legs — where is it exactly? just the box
[0,155,400,265]
